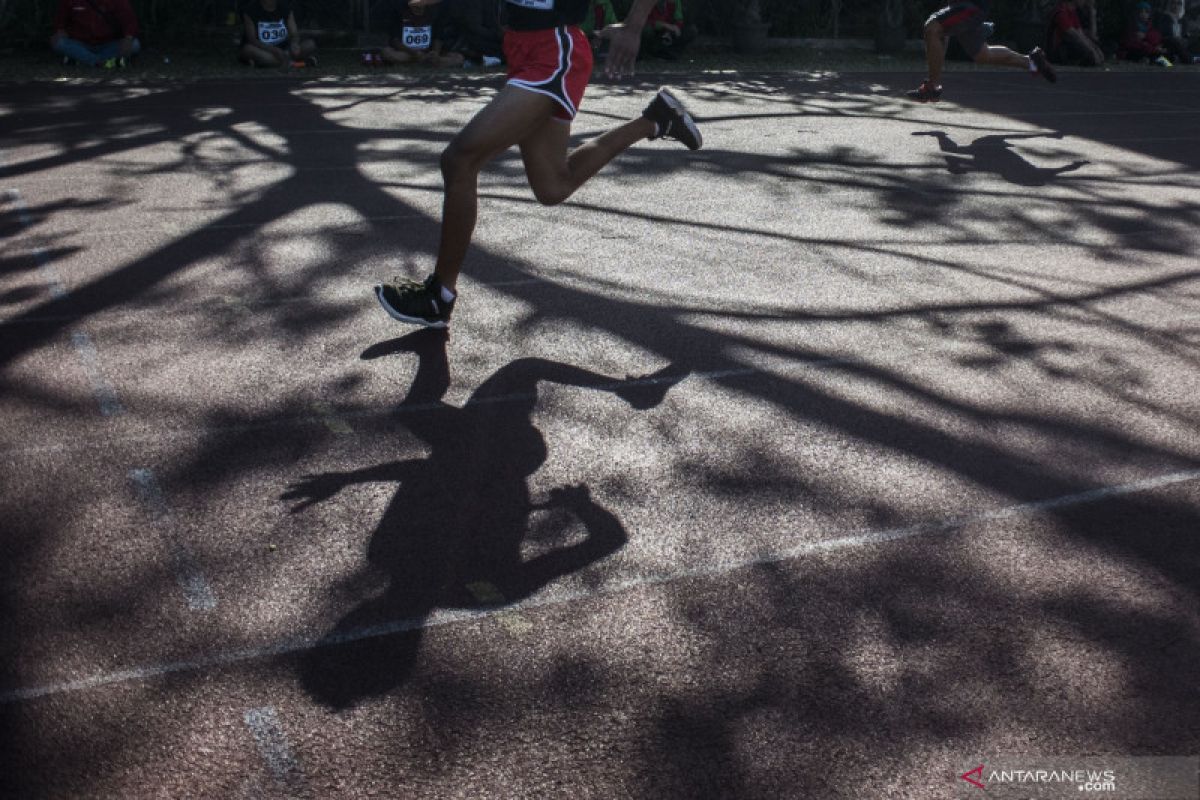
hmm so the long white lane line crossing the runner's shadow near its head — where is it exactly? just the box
[0,469,1200,705]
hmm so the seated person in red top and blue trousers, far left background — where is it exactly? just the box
[50,0,142,67]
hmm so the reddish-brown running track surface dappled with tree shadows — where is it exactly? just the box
[0,70,1200,799]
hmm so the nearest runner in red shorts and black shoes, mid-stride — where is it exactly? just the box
[374,0,702,327]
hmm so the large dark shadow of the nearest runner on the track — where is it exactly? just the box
[282,331,686,708]
